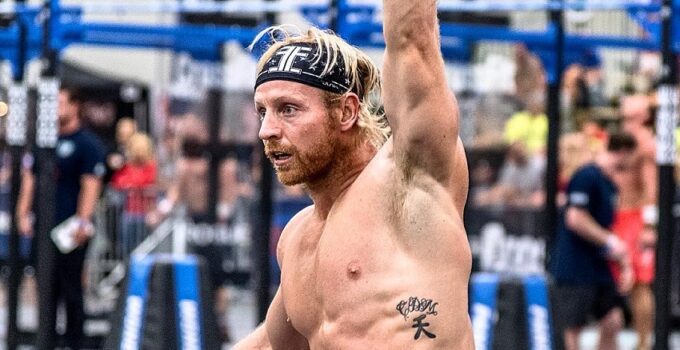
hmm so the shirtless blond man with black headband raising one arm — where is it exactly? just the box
[235,0,473,350]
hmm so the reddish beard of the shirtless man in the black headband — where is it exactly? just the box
[265,123,342,186]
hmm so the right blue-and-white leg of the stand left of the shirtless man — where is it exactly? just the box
[174,256,203,350]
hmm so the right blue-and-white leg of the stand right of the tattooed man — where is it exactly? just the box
[522,276,552,350]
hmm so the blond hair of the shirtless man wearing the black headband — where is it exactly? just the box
[250,25,391,149]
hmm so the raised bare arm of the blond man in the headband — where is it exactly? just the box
[382,0,458,183]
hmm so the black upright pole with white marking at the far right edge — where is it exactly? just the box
[654,0,678,350]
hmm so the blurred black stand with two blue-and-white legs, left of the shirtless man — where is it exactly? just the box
[109,254,219,350]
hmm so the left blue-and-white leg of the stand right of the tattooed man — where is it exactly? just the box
[470,273,498,350]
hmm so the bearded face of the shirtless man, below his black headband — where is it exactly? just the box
[255,81,356,191]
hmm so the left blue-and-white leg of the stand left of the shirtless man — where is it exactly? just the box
[120,258,153,350]
